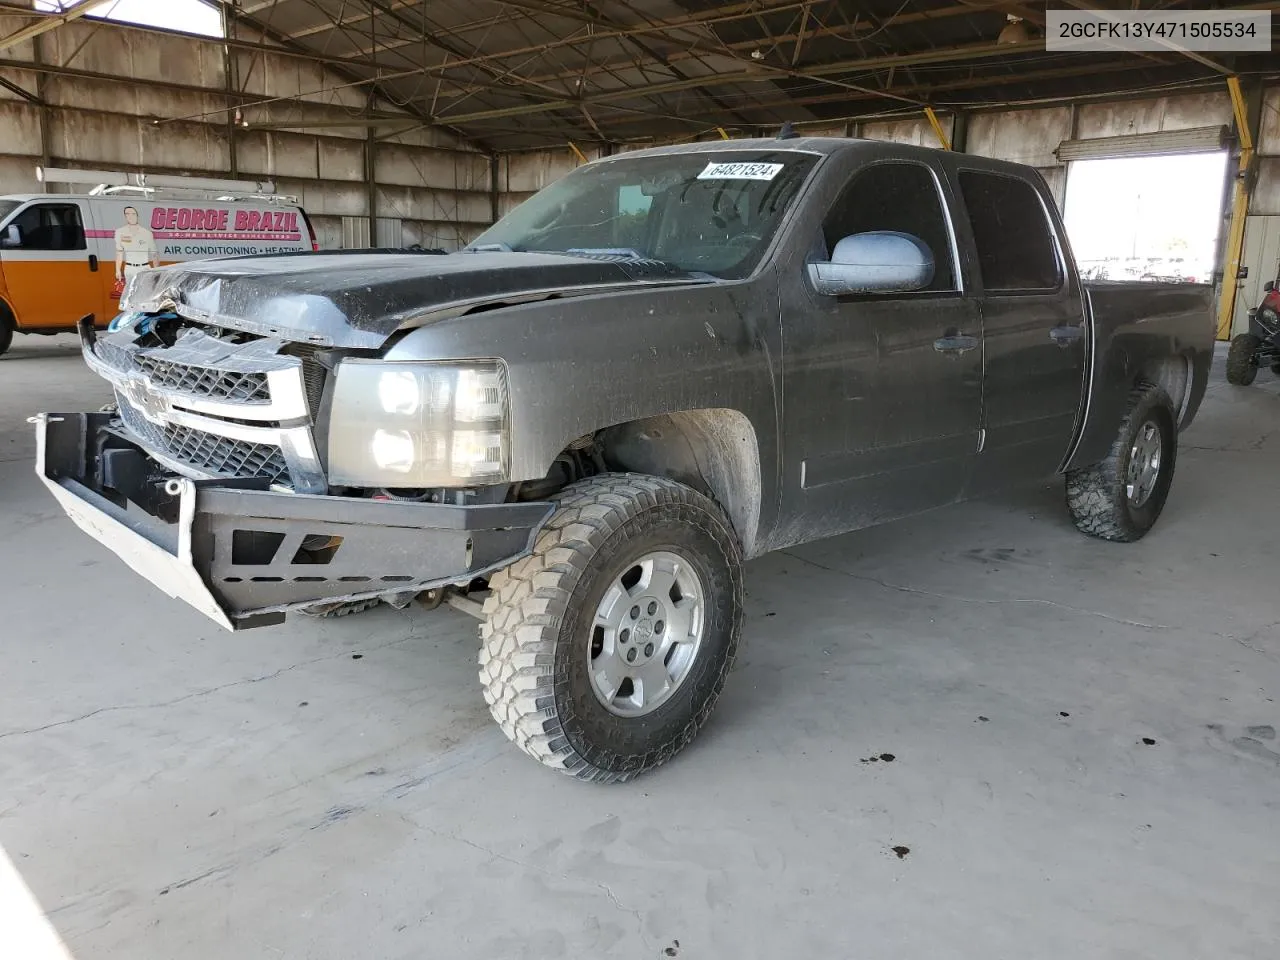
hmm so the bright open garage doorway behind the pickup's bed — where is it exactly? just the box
[1065,151,1226,283]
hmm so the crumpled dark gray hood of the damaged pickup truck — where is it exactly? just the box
[120,251,713,349]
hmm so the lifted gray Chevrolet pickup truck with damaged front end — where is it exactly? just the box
[35,138,1213,781]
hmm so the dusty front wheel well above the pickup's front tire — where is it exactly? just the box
[595,408,760,557]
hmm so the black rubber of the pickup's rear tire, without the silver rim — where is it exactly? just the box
[1066,384,1178,543]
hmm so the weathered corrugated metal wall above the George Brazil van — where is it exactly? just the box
[0,22,492,248]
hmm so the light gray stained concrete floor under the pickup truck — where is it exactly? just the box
[0,338,1280,960]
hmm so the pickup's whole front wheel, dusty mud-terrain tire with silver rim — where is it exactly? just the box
[480,474,742,782]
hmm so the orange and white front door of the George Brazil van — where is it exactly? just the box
[0,200,102,330]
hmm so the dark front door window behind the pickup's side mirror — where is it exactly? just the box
[822,163,956,291]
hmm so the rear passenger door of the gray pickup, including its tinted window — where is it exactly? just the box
[956,166,1088,494]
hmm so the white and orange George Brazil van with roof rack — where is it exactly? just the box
[0,169,320,353]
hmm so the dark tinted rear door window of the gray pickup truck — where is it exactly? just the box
[960,170,1062,293]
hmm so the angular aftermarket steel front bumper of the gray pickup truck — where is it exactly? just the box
[35,413,556,630]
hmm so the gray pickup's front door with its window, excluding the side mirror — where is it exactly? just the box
[778,161,982,545]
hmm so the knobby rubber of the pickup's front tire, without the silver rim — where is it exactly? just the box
[480,474,742,782]
